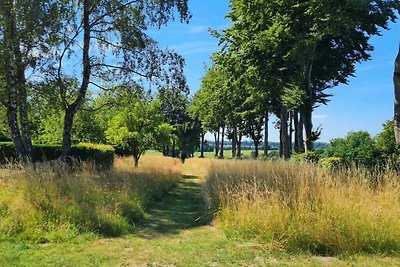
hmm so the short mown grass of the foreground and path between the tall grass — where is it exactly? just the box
[0,155,400,266]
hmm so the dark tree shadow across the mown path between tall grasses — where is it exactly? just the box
[138,175,211,239]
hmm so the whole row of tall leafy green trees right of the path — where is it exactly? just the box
[194,0,400,158]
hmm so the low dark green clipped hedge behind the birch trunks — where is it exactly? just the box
[0,142,114,168]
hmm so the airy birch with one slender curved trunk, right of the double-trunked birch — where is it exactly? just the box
[53,0,190,161]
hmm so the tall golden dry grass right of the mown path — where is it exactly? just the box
[204,161,400,255]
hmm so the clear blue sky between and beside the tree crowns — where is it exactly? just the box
[151,0,400,142]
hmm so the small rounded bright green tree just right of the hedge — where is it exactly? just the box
[106,99,173,168]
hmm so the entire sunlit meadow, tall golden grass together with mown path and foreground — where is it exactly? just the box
[0,154,400,266]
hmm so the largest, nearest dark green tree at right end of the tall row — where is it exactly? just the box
[214,0,400,157]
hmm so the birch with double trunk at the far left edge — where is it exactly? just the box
[0,0,69,162]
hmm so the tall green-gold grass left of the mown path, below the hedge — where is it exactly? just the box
[0,158,180,242]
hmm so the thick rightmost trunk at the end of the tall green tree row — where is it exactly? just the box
[303,60,314,152]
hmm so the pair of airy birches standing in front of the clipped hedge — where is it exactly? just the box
[0,0,190,161]
